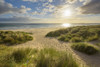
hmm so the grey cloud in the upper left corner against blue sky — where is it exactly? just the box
[0,0,31,14]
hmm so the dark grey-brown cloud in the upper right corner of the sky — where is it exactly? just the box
[80,0,100,14]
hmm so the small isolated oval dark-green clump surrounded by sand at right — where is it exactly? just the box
[71,43,99,55]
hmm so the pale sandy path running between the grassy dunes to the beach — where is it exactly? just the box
[10,28,100,67]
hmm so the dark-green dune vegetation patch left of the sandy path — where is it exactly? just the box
[0,31,33,45]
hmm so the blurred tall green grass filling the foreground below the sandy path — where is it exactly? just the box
[0,45,83,67]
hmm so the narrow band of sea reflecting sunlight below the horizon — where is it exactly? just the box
[0,23,100,30]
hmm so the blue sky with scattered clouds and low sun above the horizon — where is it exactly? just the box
[0,0,100,23]
